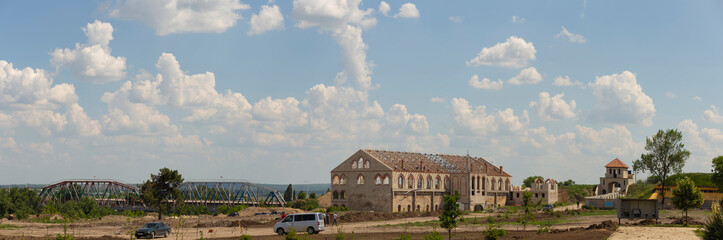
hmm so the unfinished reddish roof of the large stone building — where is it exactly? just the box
[362,149,511,177]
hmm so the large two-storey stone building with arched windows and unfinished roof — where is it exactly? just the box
[331,149,512,212]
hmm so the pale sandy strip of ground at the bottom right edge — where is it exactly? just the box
[609,226,700,240]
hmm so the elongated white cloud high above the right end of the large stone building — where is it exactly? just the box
[467,36,536,68]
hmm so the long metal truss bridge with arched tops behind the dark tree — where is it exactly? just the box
[40,179,286,209]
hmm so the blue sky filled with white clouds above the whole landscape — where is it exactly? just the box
[0,0,723,185]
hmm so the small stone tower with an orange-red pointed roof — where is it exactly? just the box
[597,158,635,195]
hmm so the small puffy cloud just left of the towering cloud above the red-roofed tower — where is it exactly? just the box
[530,92,577,121]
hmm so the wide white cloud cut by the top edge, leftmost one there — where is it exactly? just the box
[110,0,250,36]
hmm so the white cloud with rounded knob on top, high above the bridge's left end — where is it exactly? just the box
[50,20,126,83]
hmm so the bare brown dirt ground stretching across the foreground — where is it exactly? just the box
[0,207,709,240]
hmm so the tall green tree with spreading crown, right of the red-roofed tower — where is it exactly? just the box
[633,129,690,206]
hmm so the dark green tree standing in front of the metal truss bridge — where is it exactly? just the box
[141,168,183,220]
